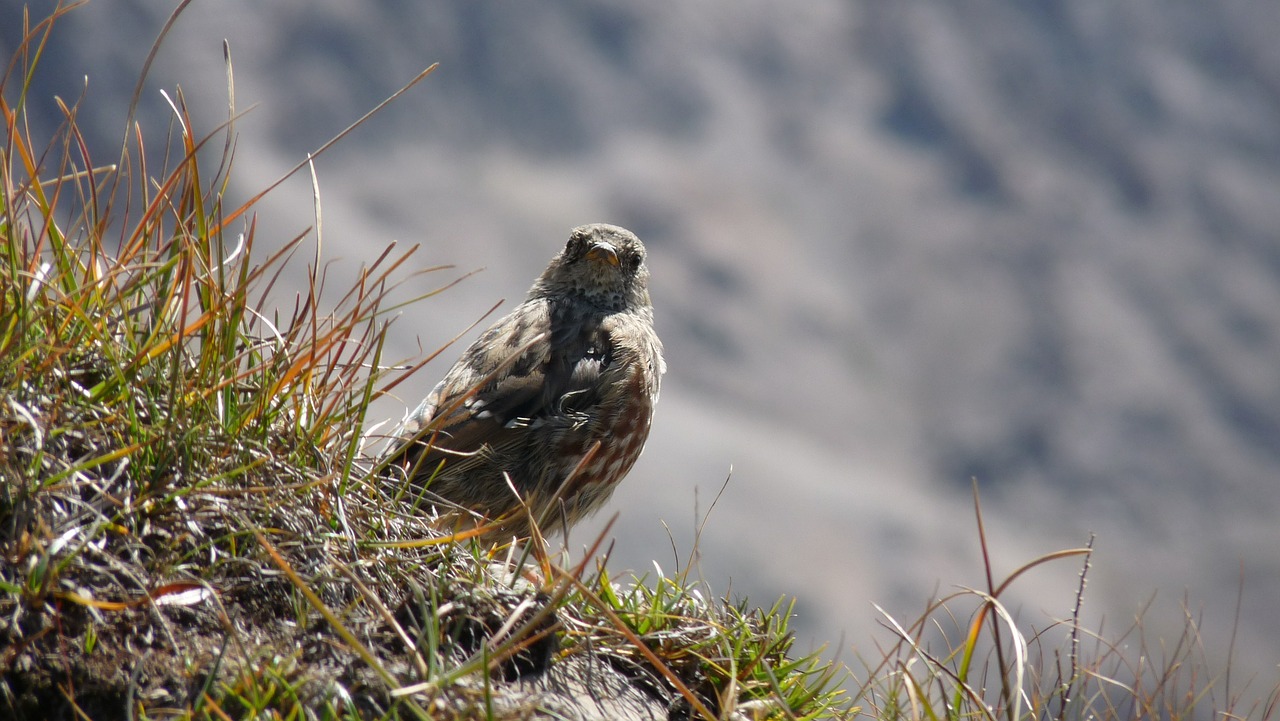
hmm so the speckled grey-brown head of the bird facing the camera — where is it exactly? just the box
[529,223,650,310]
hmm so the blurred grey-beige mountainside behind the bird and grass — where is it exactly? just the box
[0,0,1280,681]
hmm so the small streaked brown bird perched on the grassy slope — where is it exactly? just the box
[389,223,666,538]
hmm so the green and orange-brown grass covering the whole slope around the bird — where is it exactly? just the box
[0,8,1277,721]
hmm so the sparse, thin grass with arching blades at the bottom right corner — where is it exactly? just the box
[852,485,1280,721]
